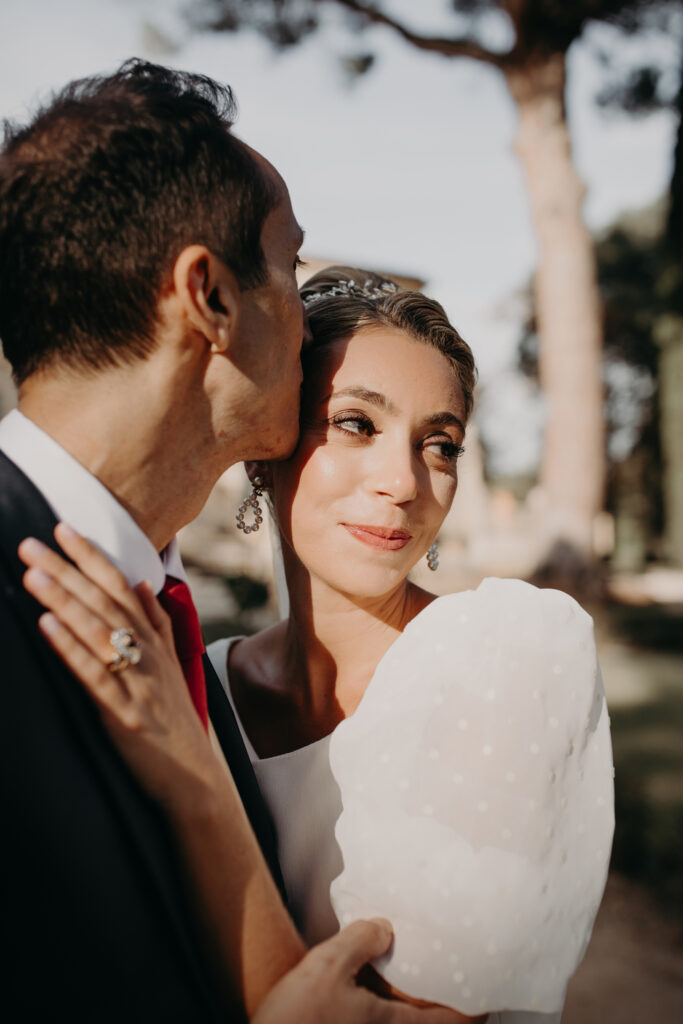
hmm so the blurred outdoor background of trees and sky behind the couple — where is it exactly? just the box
[0,0,683,1024]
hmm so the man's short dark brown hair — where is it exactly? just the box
[0,59,279,383]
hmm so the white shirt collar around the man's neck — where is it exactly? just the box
[0,409,185,593]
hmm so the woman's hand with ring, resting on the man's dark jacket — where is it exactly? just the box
[18,523,222,812]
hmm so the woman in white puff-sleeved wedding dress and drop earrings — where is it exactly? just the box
[20,268,611,1024]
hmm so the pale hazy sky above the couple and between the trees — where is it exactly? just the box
[0,0,676,467]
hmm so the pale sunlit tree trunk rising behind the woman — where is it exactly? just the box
[506,54,605,560]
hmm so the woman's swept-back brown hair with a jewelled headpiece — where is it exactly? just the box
[301,266,476,417]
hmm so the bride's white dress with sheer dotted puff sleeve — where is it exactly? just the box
[209,579,613,1024]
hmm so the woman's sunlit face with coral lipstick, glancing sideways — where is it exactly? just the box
[272,328,465,597]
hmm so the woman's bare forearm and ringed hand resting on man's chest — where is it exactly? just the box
[18,523,313,1014]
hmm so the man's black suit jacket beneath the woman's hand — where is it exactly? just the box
[0,453,282,1024]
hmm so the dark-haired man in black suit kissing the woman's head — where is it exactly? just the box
[0,61,458,1024]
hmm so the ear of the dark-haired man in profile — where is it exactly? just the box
[173,246,241,352]
